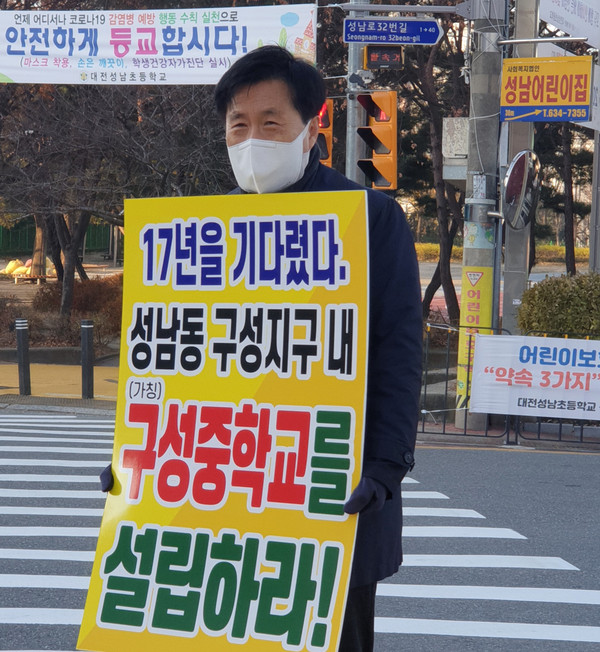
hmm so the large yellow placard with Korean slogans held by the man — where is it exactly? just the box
[78,191,368,652]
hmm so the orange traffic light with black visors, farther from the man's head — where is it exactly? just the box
[357,91,398,190]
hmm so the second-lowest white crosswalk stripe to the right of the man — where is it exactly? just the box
[377,584,600,605]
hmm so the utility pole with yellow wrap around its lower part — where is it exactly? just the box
[455,0,505,428]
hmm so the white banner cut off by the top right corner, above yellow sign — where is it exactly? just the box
[540,0,600,48]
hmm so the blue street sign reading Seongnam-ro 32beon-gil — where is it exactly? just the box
[344,18,442,45]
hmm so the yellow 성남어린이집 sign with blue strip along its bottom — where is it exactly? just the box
[500,56,592,122]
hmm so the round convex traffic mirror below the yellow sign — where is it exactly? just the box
[502,149,542,229]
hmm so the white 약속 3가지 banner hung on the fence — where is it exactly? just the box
[469,335,600,420]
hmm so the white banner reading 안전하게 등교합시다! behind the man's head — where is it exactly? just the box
[0,4,316,85]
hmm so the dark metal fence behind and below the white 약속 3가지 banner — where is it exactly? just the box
[419,323,600,446]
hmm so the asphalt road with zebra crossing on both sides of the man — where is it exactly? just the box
[0,410,600,652]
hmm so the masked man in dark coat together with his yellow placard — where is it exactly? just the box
[95,47,422,652]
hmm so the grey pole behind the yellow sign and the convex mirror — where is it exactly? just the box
[502,0,539,335]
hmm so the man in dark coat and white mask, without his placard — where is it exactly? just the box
[215,46,422,652]
